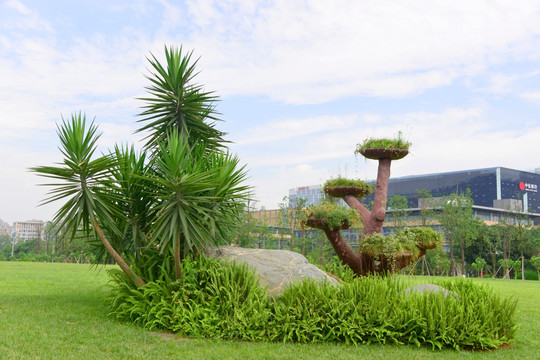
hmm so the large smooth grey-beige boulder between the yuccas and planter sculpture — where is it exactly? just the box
[207,246,339,297]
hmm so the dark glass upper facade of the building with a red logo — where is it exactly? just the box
[380,167,540,214]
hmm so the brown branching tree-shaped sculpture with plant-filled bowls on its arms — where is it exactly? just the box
[305,136,442,276]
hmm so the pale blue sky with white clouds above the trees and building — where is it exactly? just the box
[0,0,540,224]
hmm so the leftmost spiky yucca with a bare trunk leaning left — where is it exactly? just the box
[31,113,144,286]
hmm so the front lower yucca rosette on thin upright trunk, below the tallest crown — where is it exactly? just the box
[148,132,248,279]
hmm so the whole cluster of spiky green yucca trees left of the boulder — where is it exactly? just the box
[32,47,248,286]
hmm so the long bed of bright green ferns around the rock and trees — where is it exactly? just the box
[109,257,516,349]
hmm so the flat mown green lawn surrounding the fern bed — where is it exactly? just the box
[0,262,540,360]
